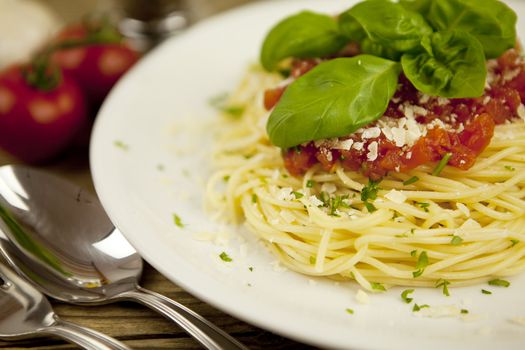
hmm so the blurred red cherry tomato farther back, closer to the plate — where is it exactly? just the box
[51,24,139,108]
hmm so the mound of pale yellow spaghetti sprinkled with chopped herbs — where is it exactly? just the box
[207,68,525,291]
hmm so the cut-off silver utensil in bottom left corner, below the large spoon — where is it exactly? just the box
[0,263,129,350]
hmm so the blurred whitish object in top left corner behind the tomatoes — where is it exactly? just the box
[0,0,62,69]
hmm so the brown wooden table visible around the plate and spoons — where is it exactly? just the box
[0,0,316,350]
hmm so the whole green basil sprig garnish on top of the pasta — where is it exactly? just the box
[261,0,516,148]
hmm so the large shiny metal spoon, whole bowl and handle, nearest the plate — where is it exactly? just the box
[0,165,247,350]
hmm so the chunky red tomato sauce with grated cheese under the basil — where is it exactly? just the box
[265,49,525,180]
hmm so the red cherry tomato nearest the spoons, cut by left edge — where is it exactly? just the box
[0,66,87,163]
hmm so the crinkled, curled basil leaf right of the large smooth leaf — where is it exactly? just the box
[401,31,487,98]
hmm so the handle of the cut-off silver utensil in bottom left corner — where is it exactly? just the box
[40,317,131,350]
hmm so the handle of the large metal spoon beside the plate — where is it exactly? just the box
[119,286,248,350]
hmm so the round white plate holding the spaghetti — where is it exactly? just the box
[91,0,525,350]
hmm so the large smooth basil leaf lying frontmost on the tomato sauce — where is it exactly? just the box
[266,55,401,148]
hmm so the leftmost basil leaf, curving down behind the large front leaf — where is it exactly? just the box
[260,11,347,71]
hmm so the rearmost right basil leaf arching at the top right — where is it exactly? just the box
[423,0,517,58]
